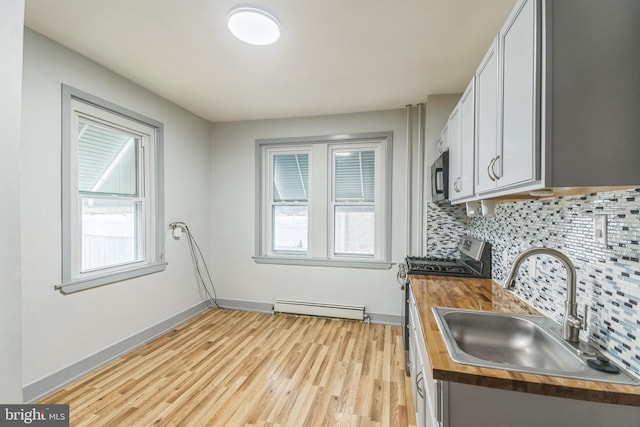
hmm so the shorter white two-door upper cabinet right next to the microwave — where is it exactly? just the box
[448,79,475,203]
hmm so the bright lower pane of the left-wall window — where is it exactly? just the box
[80,198,144,272]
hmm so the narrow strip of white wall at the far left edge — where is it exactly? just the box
[0,0,24,403]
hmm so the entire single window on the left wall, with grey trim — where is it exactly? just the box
[58,85,165,293]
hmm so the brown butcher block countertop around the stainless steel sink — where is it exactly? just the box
[410,275,640,406]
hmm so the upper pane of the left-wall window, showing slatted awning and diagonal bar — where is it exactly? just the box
[78,119,138,195]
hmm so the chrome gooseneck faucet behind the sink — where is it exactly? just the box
[504,248,585,343]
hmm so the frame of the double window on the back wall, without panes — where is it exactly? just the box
[253,132,393,269]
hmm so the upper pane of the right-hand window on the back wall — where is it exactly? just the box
[335,151,376,202]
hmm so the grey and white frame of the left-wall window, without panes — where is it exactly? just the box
[56,84,166,294]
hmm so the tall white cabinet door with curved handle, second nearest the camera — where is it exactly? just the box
[475,37,502,194]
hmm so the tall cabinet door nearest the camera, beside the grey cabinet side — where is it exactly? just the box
[496,0,540,188]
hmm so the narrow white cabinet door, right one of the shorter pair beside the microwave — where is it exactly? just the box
[459,78,476,199]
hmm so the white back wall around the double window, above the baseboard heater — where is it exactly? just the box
[210,110,406,316]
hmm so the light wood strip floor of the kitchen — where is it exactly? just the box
[38,309,415,426]
